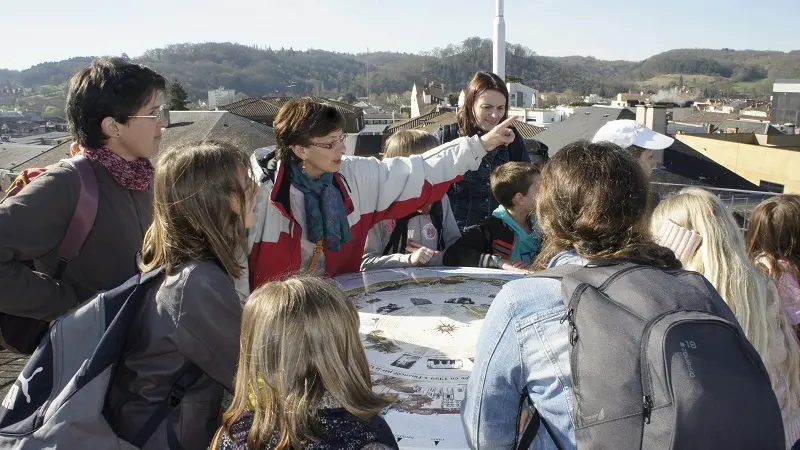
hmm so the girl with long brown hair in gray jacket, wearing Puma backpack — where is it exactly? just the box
[106,142,257,449]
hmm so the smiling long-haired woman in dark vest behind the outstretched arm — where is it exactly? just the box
[436,72,531,231]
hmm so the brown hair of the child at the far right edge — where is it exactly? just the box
[745,194,800,280]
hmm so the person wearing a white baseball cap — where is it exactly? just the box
[592,119,675,178]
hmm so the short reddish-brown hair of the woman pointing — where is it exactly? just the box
[273,97,346,164]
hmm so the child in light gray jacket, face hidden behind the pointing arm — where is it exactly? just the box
[361,130,461,271]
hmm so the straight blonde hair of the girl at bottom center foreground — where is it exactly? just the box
[223,276,395,449]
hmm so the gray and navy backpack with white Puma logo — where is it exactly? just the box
[0,269,202,450]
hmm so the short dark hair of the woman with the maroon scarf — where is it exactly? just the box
[66,58,166,148]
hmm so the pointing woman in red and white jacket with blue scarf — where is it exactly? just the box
[245,98,514,293]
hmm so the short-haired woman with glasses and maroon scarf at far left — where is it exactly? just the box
[0,58,166,330]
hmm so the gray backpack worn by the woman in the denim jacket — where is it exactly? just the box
[517,261,786,450]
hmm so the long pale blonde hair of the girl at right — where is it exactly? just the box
[651,188,800,417]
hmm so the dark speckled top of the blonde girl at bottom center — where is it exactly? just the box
[220,394,378,450]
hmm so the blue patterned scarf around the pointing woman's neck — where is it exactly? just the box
[289,164,352,252]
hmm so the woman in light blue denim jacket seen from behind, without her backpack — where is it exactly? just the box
[461,141,680,449]
